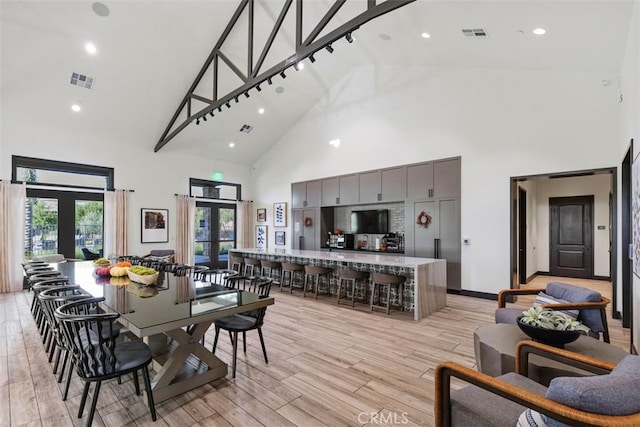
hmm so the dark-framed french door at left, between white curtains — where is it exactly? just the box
[25,188,104,259]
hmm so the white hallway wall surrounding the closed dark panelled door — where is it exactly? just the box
[536,174,611,277]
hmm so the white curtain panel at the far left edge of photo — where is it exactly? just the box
[0,181,27,293]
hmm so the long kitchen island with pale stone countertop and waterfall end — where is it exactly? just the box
[229,249,447,320]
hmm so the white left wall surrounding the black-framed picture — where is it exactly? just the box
[0,110,251,255]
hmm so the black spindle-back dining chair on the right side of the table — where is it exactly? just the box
[211,276,273,378]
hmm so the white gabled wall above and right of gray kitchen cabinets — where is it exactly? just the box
[253,66,619,293]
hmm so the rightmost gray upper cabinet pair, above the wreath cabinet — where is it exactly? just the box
[407,159,460,199]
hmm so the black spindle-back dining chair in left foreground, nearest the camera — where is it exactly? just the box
[55,298,157,426]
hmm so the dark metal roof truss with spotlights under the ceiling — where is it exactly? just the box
[154,0,415,152]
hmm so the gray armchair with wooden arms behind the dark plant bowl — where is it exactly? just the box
[495,282,611,342]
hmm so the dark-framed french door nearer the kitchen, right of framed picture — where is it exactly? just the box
[195,202,236,268]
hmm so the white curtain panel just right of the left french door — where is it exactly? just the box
[102,190,129,258]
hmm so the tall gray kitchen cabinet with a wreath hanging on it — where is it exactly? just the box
[405,198,462,290]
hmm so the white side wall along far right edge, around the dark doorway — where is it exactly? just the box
[618,0,640,349]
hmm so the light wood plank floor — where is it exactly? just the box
[0,277,629,426]
